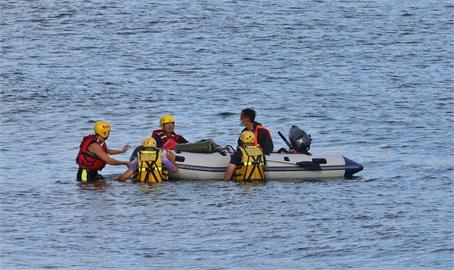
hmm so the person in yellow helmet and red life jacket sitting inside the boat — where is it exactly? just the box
[151,115,188,150]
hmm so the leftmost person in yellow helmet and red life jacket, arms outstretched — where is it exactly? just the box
[76,121,129,182]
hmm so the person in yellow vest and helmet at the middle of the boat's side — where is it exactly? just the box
[224,130,266,181]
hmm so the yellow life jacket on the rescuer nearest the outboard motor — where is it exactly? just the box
[233,145,265,181]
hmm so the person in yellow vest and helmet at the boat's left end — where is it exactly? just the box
[117,137,178,183]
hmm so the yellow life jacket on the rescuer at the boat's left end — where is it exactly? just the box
[135,150,169,183]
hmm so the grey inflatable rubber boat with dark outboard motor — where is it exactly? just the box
[170,126,363,180]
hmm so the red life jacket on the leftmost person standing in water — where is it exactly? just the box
[76,135,108,170]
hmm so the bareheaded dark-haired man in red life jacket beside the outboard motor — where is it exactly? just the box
[238,108,274,154]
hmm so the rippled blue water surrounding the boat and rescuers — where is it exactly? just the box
[0,0,454,269]
